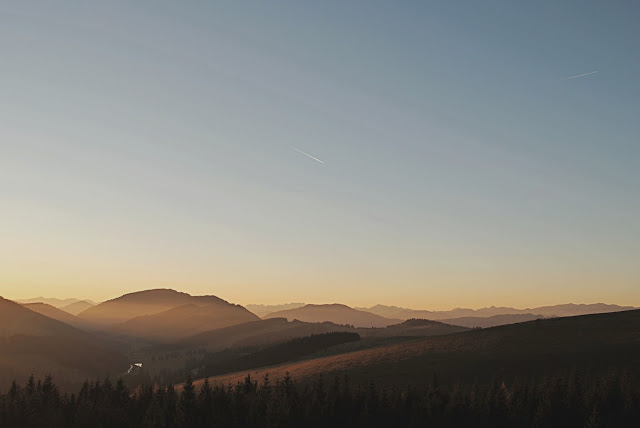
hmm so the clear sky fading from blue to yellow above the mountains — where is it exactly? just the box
[0,0,640,309]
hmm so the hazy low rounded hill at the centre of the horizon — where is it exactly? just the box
[264,304,403,327]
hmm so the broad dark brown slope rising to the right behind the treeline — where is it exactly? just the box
[194,310,640,385]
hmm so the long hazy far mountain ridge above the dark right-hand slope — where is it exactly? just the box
[357,303,636,320]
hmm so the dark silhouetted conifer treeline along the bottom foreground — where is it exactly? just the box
[0,373,640,428]
